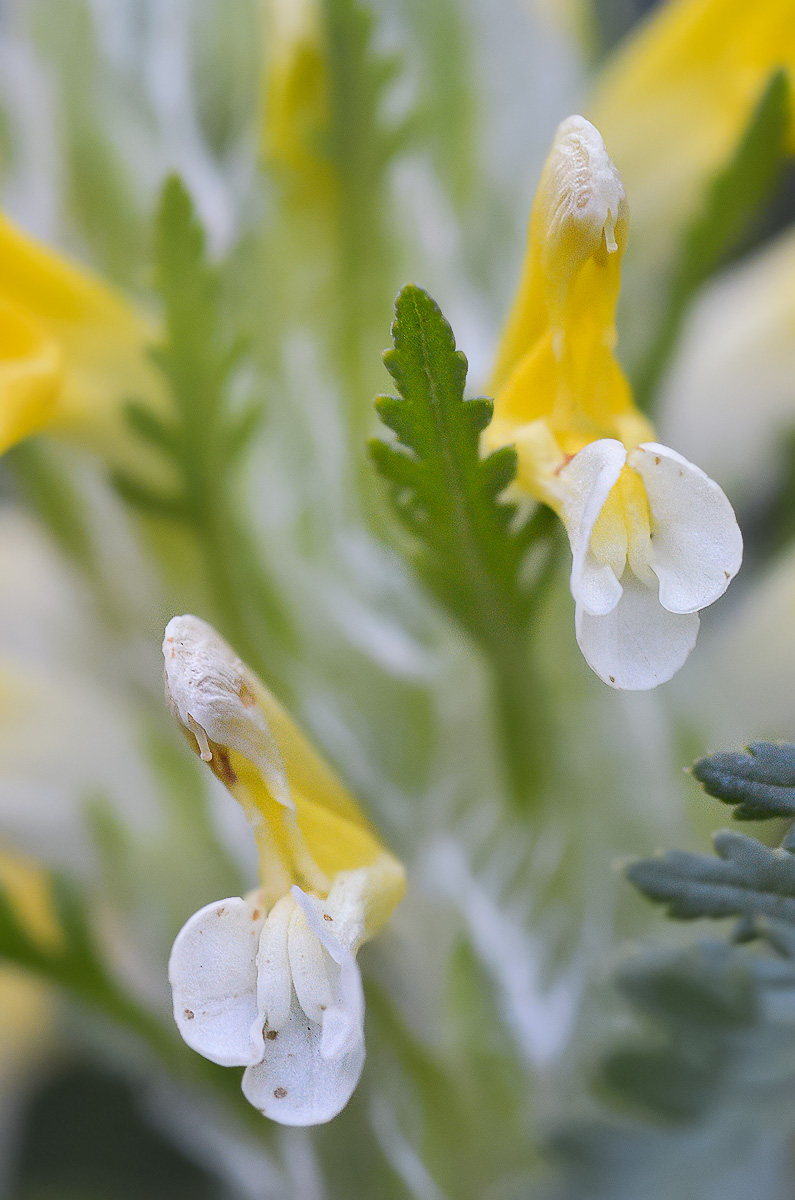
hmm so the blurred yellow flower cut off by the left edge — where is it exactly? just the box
[0,215,161,457]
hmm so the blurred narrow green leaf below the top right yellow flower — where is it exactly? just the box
[633,68,790,408]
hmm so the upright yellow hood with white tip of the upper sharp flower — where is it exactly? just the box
[486,116,653,489]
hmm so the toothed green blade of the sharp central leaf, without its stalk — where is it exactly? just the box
[371,284,542,644]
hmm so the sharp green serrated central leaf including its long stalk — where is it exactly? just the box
[371,283,556,804]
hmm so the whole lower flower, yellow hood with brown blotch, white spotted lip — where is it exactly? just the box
[163,616,405,1126]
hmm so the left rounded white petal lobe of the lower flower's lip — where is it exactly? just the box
[168,896,264,1067]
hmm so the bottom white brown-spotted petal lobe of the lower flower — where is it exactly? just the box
[243,996,364,1126]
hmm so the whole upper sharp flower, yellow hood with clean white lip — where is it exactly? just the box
[486,116,742,689]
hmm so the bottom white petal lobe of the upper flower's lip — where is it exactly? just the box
[574,570,699,691]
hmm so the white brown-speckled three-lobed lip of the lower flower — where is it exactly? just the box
[169,888,364,1124]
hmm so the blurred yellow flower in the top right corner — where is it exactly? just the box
[587,0,795,241]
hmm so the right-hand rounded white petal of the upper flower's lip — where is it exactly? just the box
[628,442,742,613]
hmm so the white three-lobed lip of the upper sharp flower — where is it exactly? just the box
[560,439,742,690]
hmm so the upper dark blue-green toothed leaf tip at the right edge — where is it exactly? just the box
[693,742,795,821]
